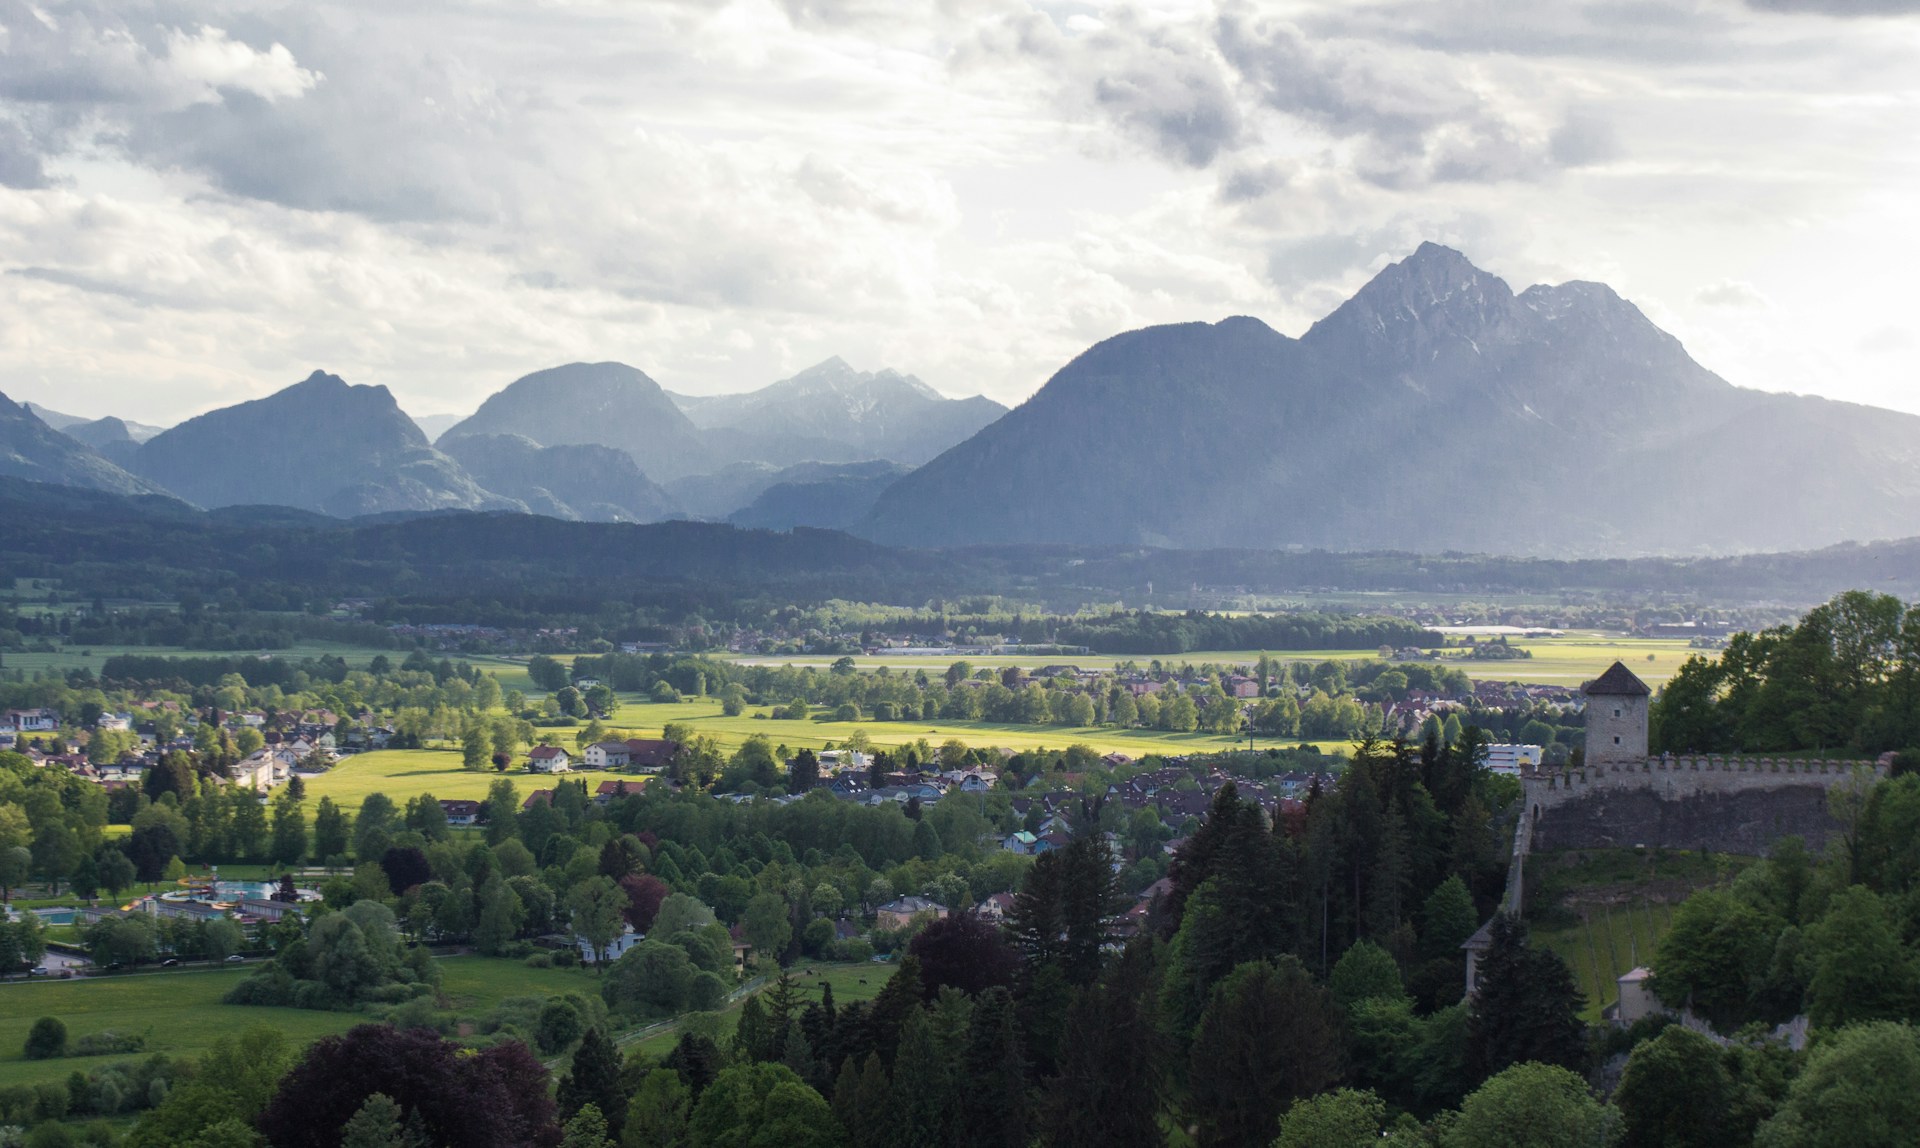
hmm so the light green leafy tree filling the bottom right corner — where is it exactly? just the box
[1753,1021,1920,1148]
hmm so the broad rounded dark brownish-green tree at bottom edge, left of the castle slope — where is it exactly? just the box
[1187,956,1346,1148]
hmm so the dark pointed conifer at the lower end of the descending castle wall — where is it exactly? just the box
[1469,914,1586,1079]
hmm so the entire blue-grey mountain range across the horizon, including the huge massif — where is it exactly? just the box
[11,244,1920,557]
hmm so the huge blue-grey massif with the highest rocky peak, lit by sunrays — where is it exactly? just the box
[860,244,1920,555]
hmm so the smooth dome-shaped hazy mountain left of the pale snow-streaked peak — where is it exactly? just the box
[436,363,714,482]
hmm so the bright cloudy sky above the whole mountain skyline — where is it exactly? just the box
[0,0,1920,424]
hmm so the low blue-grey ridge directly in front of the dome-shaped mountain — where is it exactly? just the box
[445,434,678,522]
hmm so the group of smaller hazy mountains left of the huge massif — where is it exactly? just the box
[0,359,1004,530]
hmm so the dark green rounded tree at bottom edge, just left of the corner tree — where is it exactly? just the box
[1613,1025,1751,1148]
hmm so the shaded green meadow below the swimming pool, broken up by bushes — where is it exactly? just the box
[0,956,606,1087]
